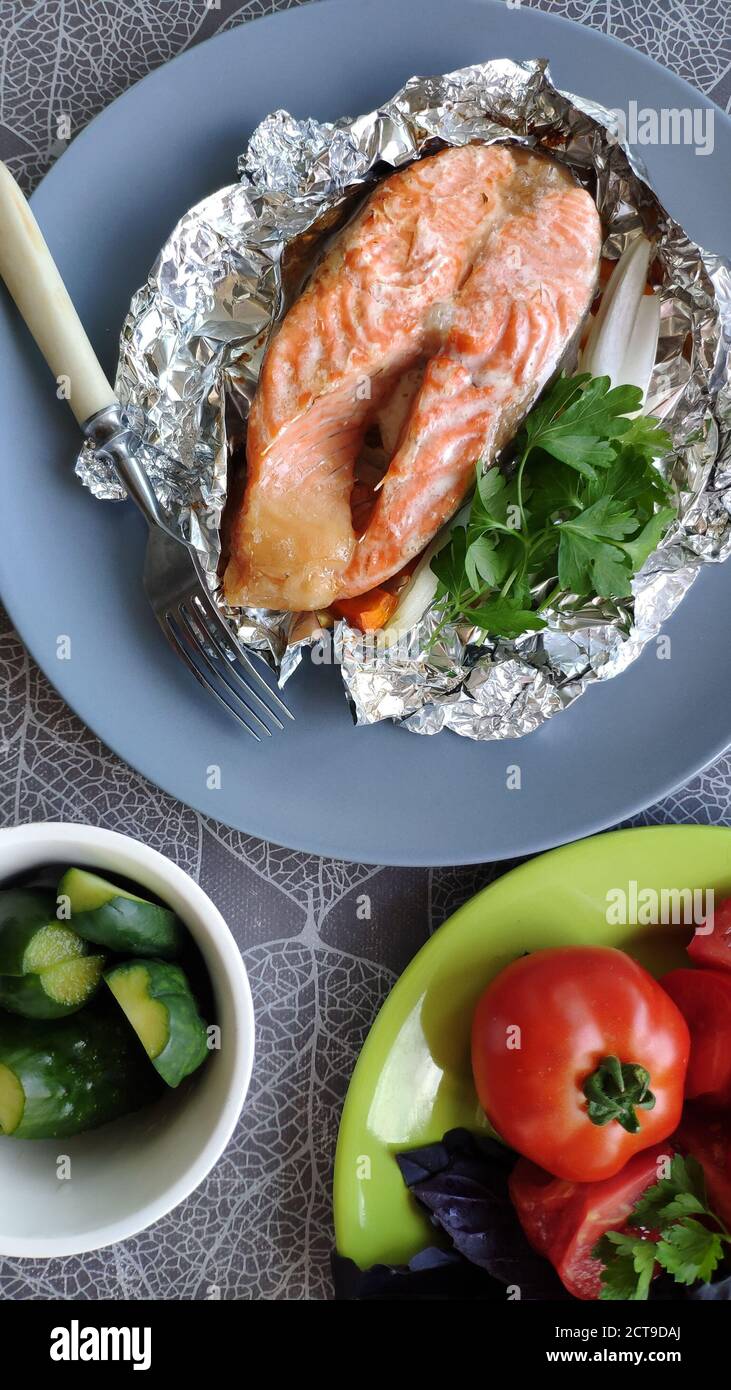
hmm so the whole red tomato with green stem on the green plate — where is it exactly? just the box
[473,947,689,1183]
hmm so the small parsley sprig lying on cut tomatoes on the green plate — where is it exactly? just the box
[593,1154,731,1301]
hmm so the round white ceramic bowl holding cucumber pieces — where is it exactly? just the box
[0,823,254,1258]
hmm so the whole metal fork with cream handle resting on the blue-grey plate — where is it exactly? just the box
[0,163,293,742]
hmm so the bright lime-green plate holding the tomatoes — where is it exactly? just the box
[334,826,731,1269]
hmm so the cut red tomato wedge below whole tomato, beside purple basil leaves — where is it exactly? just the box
[510,1144,673,1298]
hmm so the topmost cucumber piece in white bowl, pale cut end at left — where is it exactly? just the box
[58,869,183,959]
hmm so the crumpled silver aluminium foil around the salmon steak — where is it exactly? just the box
[76,60,731,739]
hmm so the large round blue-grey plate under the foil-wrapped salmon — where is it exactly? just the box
[0,0,731,865]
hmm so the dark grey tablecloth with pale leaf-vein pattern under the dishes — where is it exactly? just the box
[0,0,731,1300]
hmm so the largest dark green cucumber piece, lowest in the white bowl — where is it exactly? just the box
[0,1006,160,1140]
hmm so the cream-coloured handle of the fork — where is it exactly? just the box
[0,163,115,425]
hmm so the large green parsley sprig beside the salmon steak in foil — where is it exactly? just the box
[431,373,675,638]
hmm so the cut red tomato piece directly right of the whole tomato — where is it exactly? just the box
[662,970,731,1105]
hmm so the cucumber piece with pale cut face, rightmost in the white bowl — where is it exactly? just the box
[104,960,208,1086]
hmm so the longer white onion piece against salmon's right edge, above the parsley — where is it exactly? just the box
[580,235,657,403]
